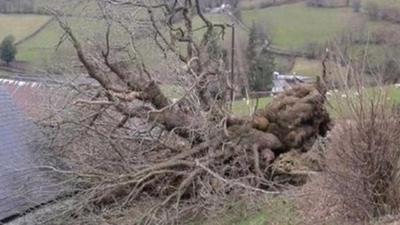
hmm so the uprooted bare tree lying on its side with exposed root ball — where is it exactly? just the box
[41,0,330,224]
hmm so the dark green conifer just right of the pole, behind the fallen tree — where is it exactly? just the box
[247,23,275,91]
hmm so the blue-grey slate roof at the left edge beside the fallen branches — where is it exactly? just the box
[0,85,57,224]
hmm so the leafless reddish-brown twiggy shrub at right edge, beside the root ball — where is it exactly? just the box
[327,90,400,219]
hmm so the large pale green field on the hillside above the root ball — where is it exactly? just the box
[242,3,354,50]
